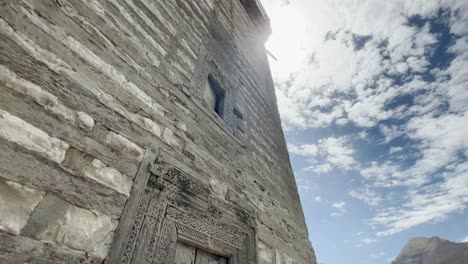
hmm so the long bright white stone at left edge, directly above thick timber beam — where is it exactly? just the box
[0,109,70,163]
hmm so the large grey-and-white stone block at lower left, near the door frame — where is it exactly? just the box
[22,195,117,258]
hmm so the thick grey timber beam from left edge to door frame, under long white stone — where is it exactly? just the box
[0,137,127,218]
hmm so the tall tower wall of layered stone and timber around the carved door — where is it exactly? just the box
[0,0,316,264]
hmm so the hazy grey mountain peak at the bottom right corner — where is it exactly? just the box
[392,237,468,264]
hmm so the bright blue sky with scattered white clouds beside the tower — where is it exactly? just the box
[262,0,468,264]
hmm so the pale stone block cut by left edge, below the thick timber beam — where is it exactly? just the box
[0,179,45,235]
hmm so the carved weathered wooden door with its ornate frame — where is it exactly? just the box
[105,146,256,264]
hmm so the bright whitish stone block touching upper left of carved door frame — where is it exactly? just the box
[83,159,133,196]
